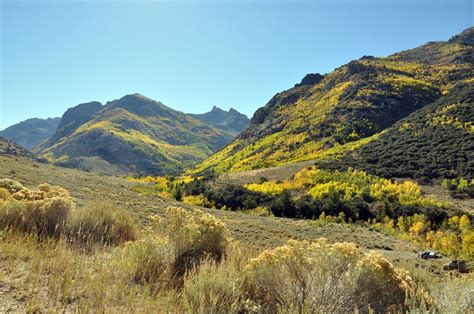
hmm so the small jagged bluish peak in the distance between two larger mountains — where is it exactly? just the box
[190,106,250,135]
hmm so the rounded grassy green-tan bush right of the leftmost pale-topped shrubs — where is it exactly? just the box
[69,203,138,245]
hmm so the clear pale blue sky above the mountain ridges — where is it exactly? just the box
[0,0,474,129]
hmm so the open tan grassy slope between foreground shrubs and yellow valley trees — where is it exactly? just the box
[0,157,422,251]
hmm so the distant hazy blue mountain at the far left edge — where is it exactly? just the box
[0,118,61,149]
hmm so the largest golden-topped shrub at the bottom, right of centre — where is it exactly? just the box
[244,239,411,313]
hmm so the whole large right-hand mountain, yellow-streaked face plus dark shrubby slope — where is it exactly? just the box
[192,28,474,177]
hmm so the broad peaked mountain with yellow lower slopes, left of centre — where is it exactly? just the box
[35,94,232,174]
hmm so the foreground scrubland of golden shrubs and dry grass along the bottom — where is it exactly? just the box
[0,167,474,313]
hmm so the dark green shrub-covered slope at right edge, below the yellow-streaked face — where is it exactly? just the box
[330,84,474,180]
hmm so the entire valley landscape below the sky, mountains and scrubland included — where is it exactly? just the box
[0,27,474,313]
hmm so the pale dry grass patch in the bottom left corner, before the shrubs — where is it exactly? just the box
[0,231,172,312]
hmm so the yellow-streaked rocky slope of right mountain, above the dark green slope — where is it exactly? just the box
[193,28,474,178]
